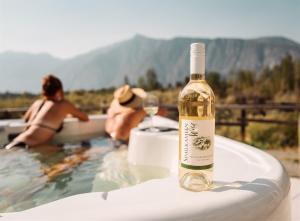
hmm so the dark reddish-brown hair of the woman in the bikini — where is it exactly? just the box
[42,74,63,97]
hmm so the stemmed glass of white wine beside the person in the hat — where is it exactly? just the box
[143,93,159,132]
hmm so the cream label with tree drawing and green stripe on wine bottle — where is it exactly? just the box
[179,117,215,170]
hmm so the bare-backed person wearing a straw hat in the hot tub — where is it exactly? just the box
[105,85,147,142]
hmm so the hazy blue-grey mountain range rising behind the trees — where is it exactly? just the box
[0,35,300,91]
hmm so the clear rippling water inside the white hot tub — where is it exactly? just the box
[0,138,169,212]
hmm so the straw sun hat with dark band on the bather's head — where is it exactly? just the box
[114,84,147,108]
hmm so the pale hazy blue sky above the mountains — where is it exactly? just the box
[0,0,300,58]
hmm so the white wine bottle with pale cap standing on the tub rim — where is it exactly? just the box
[178,43,215,191]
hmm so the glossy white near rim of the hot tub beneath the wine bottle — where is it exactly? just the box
[0,117,291,221]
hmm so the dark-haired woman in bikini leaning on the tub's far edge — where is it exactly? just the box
[5,75,88,149]
